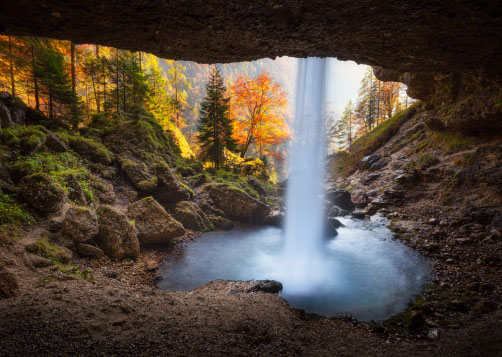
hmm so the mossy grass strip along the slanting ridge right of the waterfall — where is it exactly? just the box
[333,103,419,176]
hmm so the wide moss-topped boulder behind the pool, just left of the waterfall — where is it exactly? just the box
[204,184,270,224]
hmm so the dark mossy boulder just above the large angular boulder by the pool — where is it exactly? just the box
[152,164,193,205]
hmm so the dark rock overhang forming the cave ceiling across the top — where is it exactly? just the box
[0,0,502,81]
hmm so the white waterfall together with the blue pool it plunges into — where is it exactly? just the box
[159,58,428,320]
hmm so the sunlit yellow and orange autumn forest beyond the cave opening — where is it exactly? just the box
[0,36,412,181]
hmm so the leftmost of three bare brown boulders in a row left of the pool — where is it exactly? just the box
[61,207,99,245]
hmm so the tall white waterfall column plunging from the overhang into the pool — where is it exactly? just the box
[281,57,329,294]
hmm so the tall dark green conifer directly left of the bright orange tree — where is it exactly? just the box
[197,67,237,169]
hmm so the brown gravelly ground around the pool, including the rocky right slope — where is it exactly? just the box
[0,110,502,356]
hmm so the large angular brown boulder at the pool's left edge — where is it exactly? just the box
[127,197,185,244]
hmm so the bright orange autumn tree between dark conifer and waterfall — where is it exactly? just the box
[230,72,290,157]
